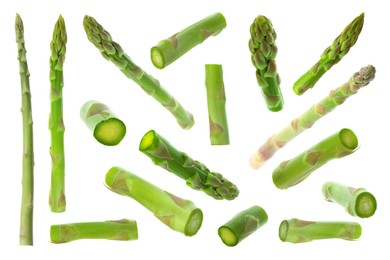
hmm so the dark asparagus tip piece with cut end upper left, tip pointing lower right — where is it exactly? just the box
[139,130,239,200]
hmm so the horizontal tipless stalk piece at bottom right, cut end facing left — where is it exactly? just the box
[279,218,362,243]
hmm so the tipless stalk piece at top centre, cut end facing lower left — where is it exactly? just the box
[150,13,226,69]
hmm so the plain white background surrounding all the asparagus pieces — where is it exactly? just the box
[0,0,390,259]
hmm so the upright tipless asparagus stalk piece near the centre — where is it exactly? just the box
[205,64,229,145]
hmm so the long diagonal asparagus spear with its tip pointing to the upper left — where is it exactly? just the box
[84,15,194,129]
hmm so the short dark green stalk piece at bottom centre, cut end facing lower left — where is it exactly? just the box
[218,205,268,246]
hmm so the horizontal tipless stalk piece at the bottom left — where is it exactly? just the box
[50,219,138,244]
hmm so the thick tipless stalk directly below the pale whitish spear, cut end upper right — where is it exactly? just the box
[272,128,358,189]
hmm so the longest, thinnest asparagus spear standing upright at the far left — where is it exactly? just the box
[15,14,34,245]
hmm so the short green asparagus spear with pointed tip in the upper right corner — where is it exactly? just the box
[293,13,364,95]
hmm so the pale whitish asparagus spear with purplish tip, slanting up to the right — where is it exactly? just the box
[250,65,375,169]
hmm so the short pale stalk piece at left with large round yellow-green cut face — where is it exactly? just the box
[80,100,126,146]
